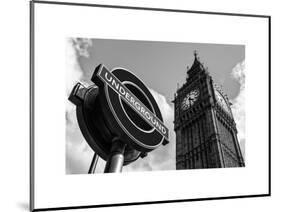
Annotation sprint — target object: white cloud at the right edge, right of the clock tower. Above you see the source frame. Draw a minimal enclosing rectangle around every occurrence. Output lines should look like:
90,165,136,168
231,61,245,158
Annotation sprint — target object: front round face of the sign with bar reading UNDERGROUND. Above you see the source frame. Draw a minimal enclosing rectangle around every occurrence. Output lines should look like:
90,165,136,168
92,64,169,152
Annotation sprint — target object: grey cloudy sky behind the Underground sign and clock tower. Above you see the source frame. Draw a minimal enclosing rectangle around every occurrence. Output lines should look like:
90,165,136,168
66,38,245,174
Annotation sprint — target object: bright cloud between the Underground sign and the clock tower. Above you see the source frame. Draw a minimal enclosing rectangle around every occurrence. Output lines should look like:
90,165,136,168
123,89,176,172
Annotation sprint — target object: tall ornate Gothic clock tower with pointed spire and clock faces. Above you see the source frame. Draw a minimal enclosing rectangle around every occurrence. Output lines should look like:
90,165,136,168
173,52,245,169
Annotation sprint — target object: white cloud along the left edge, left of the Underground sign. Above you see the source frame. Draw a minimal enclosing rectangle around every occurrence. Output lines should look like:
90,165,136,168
65,38,99,174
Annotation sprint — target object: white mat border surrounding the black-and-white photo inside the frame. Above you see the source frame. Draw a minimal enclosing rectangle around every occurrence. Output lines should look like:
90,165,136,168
31,3,269,209
